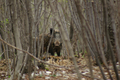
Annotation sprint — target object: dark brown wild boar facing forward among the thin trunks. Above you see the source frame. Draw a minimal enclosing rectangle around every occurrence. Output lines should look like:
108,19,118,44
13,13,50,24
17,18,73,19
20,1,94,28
33,28,62,57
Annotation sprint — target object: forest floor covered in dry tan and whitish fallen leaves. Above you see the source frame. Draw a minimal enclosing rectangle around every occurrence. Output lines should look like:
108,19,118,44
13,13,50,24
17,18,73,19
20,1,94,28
0,54,120,80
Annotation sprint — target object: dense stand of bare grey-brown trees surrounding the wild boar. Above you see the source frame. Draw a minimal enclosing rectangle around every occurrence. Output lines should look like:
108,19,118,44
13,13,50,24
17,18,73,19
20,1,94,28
0,0,120,80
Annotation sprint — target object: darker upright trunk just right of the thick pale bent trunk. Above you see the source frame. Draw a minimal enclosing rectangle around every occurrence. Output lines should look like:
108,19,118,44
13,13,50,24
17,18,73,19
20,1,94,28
25,0,34,80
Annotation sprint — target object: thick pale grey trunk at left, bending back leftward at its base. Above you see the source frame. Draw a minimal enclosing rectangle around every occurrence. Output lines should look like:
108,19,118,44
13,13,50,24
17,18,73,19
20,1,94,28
10,0,23,80
